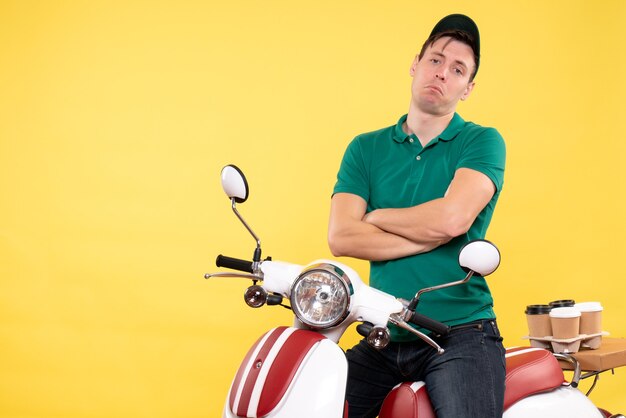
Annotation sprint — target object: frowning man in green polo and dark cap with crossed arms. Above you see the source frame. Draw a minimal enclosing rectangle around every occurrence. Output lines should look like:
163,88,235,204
328,14,505,418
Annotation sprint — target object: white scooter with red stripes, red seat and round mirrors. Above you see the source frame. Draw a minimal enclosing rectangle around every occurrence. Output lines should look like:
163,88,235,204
205,165,623,418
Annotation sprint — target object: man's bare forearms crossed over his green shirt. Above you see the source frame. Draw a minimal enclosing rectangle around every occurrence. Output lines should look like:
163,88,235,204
328,168,495,261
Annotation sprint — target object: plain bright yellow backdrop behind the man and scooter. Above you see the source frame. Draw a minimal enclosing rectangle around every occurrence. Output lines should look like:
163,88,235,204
0,0,626,418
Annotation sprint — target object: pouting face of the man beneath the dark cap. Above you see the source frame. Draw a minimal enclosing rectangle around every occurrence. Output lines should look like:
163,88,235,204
410,37,476,116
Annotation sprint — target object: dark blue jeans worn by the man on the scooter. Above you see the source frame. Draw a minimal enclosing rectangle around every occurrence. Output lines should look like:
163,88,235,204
346,320,506,418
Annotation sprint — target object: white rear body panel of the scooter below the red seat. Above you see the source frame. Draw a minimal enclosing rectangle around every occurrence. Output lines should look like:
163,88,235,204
502,386,603,418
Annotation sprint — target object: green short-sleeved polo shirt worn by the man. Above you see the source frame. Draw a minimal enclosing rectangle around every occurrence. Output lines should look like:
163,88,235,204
333,113,506,341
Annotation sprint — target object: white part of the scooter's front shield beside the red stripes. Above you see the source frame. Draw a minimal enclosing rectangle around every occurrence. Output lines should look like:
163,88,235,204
222,339,348,418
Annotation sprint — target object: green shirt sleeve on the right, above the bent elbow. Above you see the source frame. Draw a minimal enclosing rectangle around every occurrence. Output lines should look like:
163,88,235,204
456,128,506,192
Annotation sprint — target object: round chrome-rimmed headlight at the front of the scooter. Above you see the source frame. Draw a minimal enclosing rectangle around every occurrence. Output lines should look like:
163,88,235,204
290,263,353,329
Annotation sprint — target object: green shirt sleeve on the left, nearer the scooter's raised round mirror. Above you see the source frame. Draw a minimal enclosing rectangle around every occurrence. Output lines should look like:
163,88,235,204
333,137,369,202
